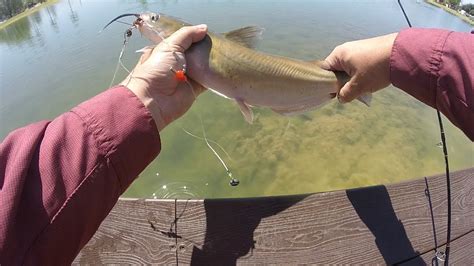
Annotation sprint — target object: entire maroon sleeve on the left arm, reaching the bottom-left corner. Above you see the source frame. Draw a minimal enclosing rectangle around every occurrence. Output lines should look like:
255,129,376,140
0,87,161,265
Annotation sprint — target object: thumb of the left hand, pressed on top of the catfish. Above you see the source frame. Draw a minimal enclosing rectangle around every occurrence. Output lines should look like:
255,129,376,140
166,24,207,52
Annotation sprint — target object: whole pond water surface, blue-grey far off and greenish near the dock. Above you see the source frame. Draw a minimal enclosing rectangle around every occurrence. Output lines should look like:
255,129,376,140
0,0,474,198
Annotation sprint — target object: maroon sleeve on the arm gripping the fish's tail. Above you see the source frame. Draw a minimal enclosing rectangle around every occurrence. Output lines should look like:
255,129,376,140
390,29,474,141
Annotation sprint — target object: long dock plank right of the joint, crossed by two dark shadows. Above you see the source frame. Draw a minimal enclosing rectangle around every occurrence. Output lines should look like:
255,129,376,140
177,169,474,264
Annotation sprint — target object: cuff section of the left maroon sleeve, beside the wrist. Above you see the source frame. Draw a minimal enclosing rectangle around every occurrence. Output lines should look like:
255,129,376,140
72,86,161,193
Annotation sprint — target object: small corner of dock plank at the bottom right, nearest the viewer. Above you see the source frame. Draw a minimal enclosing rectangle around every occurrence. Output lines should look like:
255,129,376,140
400,231,474,266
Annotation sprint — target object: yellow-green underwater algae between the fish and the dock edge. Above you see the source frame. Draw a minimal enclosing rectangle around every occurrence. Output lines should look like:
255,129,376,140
129,87,474,197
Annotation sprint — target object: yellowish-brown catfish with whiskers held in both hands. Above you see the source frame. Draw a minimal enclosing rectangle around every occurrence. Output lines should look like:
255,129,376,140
105,12,371,123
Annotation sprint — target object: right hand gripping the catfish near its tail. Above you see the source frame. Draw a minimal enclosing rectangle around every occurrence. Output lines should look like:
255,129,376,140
321,33,398,103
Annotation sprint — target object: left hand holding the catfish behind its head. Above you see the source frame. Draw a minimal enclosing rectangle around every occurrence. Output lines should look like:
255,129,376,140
120,25,207,131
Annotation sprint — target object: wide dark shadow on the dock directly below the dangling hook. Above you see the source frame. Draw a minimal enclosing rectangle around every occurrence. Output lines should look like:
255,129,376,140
191,195,309,265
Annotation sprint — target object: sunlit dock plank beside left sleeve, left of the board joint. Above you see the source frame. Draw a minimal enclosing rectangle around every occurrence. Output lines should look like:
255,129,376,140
73,199,176,265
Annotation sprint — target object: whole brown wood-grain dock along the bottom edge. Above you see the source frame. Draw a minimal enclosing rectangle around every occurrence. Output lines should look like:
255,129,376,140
74,168,474,265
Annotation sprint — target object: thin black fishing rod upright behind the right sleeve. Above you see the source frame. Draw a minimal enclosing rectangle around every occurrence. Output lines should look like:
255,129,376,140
398,0,451,265
